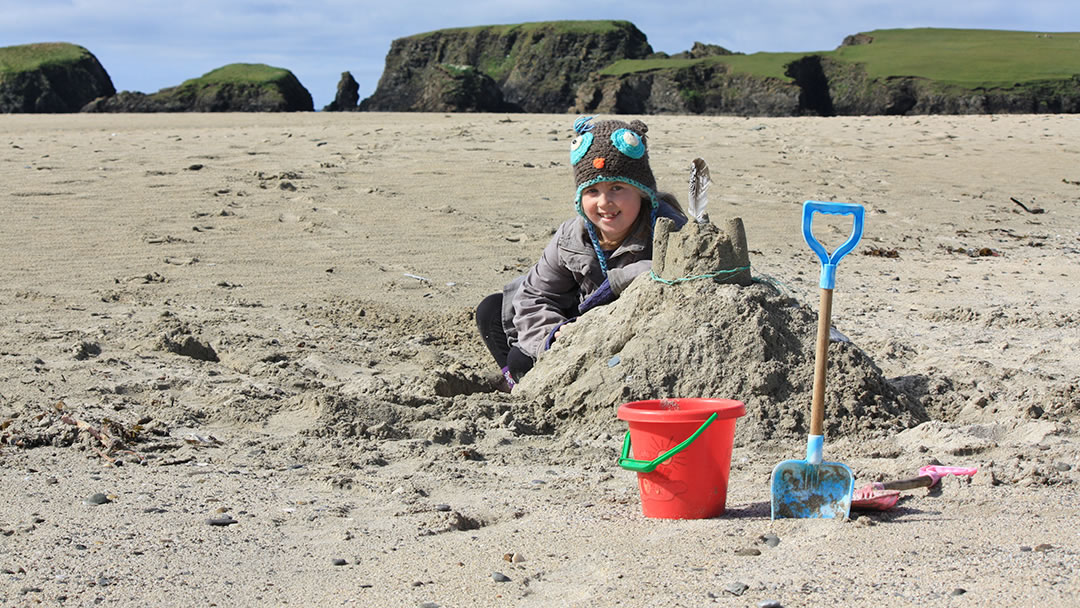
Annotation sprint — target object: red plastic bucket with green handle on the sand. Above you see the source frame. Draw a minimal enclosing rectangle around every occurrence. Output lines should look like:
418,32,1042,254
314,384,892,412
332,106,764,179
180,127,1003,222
619,398,746,519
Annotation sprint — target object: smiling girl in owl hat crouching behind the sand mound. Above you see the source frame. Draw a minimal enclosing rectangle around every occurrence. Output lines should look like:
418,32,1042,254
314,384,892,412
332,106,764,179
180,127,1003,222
476,117,686,388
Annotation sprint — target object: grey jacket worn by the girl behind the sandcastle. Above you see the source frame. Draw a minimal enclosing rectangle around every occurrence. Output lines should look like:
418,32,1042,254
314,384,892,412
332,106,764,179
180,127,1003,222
502,194,686,359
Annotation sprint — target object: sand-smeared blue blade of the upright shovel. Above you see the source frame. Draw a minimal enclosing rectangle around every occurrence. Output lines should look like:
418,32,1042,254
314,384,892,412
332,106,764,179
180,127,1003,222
772,460,855,519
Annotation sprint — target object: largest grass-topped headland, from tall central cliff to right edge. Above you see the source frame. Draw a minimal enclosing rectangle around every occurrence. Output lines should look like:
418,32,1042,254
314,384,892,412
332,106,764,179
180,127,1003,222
361,21,1080,116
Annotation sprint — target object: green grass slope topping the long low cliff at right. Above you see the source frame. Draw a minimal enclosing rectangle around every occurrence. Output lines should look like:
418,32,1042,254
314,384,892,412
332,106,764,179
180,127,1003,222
600,28,1080,89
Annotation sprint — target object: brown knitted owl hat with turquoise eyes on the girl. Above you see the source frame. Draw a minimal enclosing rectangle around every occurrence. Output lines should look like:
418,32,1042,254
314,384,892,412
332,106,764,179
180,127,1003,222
570,117,660,275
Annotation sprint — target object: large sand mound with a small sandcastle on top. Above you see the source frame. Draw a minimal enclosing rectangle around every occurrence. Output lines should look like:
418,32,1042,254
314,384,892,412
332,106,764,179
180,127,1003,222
514,218,927,443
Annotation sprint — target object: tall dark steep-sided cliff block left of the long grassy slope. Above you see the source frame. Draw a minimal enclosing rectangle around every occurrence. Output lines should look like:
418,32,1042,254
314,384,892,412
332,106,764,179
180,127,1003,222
360,22,652,112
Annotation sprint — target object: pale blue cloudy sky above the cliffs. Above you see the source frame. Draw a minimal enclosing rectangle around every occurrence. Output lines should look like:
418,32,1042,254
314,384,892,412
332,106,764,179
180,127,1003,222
0,0,1080,109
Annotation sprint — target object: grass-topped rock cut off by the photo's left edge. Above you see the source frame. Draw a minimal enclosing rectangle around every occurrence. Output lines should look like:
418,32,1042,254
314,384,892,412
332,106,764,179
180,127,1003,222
0,42,116,113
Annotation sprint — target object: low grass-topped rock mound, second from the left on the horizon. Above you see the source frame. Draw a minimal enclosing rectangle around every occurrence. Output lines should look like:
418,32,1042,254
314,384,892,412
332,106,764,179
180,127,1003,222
82,64,314,112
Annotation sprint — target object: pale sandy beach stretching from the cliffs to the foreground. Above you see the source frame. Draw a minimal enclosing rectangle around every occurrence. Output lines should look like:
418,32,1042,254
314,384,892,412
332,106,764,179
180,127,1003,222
0,113,1080,608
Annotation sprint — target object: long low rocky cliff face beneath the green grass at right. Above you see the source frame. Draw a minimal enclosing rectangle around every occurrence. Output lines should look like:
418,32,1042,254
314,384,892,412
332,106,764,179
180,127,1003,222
571,55,1080,117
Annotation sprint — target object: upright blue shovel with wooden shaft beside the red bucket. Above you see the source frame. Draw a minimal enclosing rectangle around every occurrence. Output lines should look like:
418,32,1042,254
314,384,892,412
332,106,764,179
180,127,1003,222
772,201,864,519
